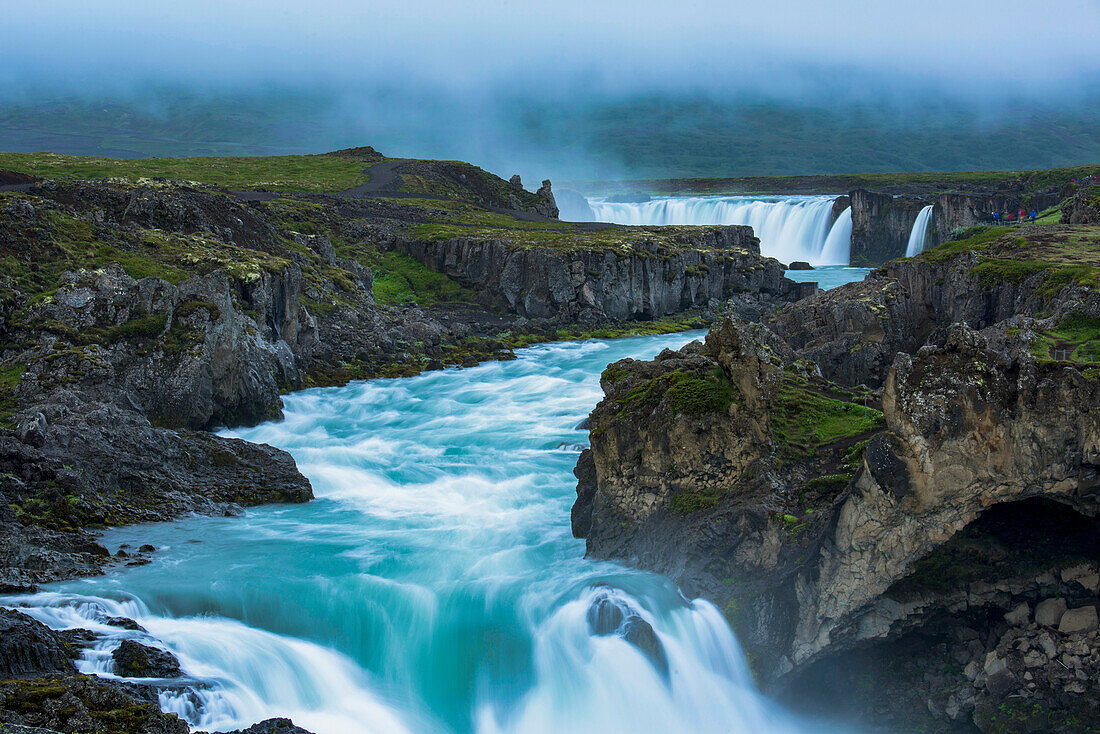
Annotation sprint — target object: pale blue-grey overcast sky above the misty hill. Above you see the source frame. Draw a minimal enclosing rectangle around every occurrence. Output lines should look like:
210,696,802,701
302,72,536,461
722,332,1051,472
0,0,1100,98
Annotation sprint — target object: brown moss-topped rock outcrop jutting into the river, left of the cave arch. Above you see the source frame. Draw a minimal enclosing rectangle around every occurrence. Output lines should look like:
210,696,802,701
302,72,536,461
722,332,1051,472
573,320,878,672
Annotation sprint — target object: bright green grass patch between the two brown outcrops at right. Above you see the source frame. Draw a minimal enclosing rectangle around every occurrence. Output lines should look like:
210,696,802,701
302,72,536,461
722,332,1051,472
770,379,884,459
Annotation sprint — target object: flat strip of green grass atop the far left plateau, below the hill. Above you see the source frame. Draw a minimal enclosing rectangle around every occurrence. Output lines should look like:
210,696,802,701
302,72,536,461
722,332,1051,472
0,153,381,193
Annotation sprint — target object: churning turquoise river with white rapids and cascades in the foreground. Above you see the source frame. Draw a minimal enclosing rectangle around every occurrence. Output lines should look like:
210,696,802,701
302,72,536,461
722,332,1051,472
0,332,849,734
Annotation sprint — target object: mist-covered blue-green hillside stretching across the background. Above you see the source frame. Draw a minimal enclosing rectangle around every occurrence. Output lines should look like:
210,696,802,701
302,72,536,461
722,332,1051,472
0,88,1100,180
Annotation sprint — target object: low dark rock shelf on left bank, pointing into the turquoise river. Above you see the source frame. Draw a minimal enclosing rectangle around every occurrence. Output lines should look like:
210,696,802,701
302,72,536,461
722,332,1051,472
0,390,312,591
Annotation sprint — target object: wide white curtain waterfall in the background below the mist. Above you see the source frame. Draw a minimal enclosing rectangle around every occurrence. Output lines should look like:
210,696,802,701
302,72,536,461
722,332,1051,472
589,196,851,265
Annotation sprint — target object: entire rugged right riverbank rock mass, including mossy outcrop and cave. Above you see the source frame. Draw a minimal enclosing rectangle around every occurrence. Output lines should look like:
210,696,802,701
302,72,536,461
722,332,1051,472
572,222,1100,732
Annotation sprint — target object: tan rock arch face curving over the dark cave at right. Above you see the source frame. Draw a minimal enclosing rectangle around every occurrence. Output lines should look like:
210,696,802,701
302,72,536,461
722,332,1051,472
791,325,1100,664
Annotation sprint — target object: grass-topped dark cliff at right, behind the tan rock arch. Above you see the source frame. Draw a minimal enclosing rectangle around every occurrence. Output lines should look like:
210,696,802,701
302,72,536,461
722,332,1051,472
773,226,1100,386
